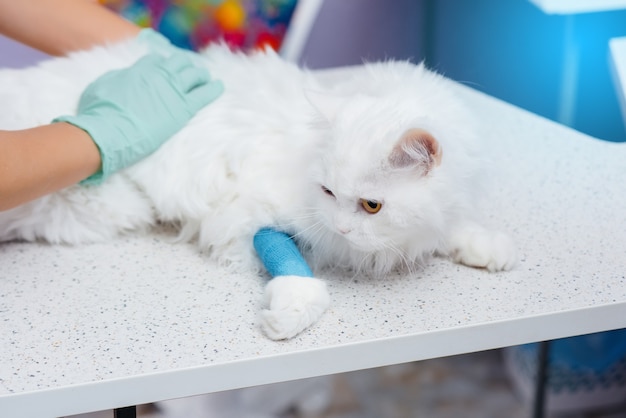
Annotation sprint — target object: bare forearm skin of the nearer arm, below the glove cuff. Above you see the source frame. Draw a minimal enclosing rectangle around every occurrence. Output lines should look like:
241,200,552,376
0,123,100,210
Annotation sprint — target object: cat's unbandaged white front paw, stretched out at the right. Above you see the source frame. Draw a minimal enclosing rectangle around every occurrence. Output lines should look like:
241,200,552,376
450,226,517,272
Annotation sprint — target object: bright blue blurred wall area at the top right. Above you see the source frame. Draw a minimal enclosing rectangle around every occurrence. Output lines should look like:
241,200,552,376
425,0,626,141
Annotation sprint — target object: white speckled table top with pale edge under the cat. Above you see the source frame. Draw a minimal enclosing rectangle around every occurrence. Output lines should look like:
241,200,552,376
0,73,626,417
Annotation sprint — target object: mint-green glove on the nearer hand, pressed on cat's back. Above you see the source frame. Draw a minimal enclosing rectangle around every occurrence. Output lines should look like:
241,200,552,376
53,53,224,184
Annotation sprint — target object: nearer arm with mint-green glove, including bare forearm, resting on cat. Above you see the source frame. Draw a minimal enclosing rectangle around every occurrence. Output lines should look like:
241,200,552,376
0,54,223,210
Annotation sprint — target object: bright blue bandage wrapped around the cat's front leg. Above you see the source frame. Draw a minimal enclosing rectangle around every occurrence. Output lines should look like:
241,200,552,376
254,228,313,277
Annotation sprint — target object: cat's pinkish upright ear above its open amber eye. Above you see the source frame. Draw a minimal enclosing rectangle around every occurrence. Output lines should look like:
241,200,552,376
389,129,442,173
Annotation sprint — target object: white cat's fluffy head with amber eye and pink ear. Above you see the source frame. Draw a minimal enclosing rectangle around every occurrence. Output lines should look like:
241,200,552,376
308,66,472,255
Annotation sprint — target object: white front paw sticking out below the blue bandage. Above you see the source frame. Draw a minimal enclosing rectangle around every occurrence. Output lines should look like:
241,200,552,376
261,276,330,340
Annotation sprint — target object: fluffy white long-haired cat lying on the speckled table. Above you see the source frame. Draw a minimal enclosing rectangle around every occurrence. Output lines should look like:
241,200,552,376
0,38,516,339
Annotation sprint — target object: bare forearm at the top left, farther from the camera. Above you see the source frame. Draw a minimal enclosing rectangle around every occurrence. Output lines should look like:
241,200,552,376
0,0,140,55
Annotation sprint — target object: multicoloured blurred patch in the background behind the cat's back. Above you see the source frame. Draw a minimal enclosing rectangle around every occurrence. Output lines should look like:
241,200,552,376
100,0,297,51
